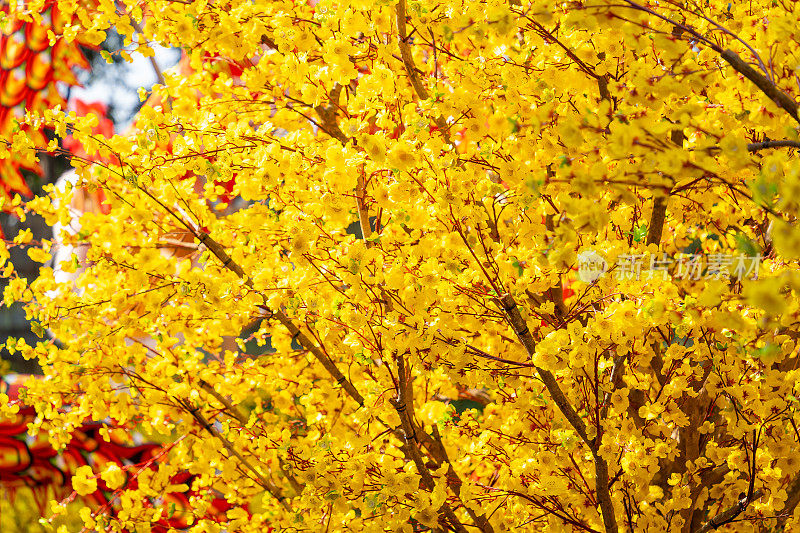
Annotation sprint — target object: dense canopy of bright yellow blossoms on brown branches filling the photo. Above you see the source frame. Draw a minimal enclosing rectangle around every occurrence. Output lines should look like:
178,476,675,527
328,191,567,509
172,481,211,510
4,0,800,532
